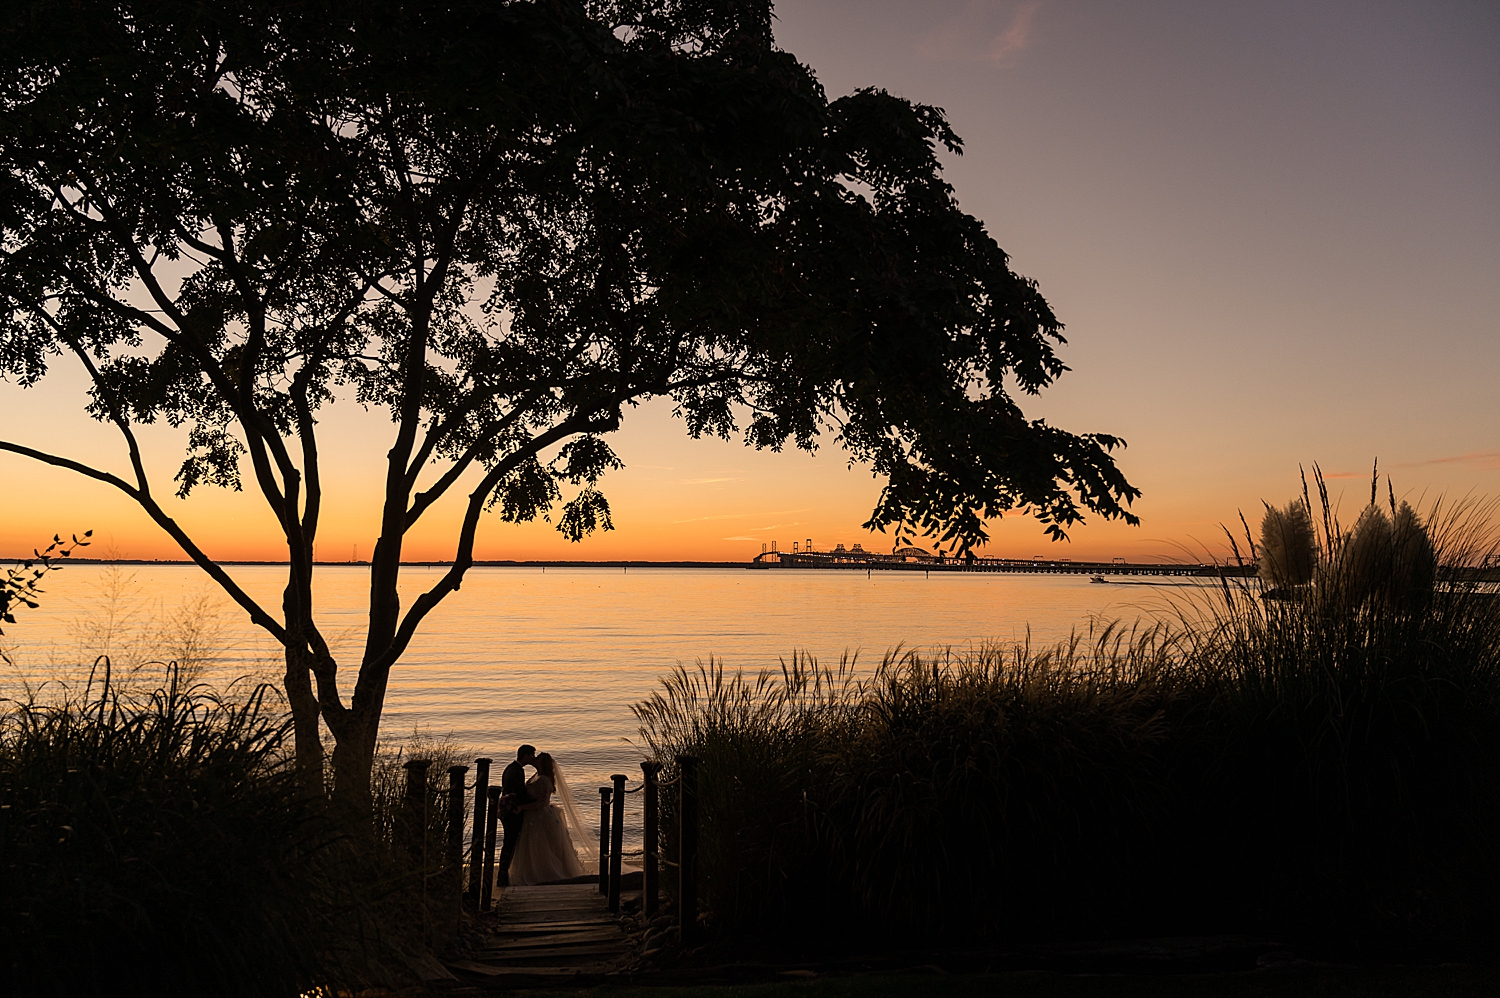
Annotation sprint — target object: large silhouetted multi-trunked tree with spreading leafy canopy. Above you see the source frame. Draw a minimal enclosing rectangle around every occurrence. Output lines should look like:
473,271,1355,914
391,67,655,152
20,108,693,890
0,0,1139,803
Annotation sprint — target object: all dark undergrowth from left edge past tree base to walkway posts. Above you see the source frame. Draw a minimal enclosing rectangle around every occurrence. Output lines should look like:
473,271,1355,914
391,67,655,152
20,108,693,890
0,665,480,995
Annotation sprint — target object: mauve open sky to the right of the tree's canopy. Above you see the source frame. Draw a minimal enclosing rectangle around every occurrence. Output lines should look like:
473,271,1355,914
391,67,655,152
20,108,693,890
762,0,1500,546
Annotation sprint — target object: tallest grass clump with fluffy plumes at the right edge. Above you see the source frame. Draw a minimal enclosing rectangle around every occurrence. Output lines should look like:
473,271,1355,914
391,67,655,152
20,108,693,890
1179,480,1500,942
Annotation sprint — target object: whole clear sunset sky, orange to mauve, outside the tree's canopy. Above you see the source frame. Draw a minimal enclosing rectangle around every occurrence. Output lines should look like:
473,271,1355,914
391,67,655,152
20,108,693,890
0,0,1500,560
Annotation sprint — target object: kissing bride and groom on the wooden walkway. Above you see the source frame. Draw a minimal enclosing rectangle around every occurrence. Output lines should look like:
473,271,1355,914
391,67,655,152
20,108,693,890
500,744,599,887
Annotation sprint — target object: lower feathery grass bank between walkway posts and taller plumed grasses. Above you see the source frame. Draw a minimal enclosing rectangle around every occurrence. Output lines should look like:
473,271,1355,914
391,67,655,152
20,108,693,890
636,629,1194,939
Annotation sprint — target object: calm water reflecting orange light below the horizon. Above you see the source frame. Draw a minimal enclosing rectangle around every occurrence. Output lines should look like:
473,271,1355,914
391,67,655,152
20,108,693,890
0,566,1194,846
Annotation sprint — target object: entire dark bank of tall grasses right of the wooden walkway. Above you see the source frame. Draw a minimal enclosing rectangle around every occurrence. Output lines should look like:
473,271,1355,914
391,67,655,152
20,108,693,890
636,510,1500,951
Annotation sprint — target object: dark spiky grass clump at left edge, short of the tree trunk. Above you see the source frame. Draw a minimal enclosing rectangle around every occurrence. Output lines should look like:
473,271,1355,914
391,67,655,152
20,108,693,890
0,662,336,995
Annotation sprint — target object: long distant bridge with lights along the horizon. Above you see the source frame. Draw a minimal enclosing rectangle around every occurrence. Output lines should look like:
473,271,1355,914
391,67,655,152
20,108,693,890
749,551,1256,578
